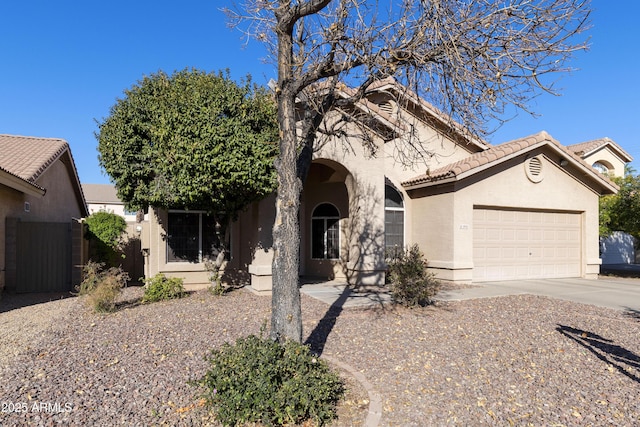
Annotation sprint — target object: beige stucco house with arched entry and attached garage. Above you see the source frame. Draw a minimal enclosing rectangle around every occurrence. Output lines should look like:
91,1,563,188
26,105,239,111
134,80,631,292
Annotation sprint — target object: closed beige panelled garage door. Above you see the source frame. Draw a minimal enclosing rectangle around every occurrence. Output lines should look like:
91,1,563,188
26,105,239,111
473,209,582,282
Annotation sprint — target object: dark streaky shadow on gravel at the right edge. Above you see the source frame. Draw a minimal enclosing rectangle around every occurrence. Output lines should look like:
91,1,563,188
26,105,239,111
556,325,640,383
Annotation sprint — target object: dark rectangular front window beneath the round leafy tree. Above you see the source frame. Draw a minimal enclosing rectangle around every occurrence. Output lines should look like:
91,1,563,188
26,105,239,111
167,211,220,262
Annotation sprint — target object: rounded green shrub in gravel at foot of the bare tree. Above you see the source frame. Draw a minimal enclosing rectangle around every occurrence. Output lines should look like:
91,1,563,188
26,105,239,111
198,335,344,426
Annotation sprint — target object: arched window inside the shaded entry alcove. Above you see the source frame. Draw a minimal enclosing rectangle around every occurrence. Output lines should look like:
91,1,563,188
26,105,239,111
311,203,340,259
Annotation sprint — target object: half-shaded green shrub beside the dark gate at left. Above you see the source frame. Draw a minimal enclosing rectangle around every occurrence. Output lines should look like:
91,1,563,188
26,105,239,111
85,211,127,267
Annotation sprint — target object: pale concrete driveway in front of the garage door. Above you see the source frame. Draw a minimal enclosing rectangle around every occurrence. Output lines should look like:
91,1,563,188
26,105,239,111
437,277,640,312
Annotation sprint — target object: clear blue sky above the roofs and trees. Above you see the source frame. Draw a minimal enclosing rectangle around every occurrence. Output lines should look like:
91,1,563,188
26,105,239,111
0,0,640,183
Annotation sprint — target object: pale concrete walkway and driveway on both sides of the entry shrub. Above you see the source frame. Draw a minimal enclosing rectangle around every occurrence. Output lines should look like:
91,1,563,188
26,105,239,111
300,276,640,312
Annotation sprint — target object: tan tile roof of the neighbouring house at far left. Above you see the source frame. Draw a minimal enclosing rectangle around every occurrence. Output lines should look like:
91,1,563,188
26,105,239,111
0,135,69,184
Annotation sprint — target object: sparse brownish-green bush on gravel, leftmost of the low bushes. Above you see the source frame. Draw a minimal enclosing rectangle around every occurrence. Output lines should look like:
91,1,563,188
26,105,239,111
76,261,129,312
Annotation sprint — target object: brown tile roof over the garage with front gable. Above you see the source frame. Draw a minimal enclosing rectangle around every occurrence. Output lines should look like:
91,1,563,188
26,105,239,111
402,131,617,193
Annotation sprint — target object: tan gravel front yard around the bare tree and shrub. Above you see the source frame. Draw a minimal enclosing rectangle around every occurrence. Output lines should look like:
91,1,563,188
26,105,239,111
0,288,640,426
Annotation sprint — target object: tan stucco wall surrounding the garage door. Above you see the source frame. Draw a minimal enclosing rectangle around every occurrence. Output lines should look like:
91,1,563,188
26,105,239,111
412,153,600,281
